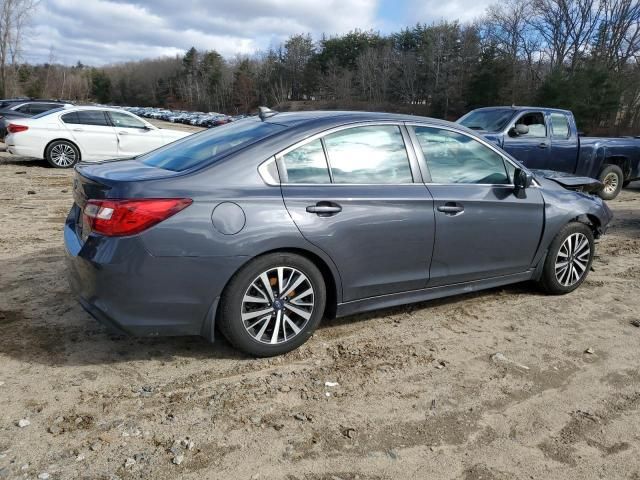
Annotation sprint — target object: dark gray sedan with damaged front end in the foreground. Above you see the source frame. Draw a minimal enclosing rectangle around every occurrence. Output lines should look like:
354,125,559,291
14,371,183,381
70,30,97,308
64,108,612,356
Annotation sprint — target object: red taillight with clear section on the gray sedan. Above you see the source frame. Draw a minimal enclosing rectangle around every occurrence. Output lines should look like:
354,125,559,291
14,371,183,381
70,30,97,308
83,198,193,237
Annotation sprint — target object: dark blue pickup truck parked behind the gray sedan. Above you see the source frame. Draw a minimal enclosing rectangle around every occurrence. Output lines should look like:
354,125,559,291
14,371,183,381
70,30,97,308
458,107,640,200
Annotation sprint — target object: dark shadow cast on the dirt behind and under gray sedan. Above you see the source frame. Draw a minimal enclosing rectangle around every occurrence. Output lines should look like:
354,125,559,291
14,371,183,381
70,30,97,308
0,248,539,366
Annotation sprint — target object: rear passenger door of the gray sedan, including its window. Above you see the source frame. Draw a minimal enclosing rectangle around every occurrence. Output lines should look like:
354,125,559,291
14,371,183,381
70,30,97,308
277,124,434,301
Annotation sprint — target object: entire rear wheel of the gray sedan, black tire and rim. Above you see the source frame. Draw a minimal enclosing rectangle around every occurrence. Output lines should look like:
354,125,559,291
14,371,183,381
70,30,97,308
218,253,326,357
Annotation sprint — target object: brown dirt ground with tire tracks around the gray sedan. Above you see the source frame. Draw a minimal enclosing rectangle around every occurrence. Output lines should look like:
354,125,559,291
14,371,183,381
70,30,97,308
0,121,640,480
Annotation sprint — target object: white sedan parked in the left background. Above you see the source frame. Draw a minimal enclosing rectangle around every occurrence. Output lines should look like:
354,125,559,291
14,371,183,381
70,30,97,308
5,107,190,168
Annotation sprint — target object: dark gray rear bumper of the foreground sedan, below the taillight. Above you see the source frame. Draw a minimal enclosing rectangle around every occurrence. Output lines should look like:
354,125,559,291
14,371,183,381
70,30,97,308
64,206,244,340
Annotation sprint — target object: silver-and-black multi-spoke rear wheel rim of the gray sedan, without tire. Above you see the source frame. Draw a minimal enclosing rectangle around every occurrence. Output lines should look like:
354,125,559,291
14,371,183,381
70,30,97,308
240,266,315,344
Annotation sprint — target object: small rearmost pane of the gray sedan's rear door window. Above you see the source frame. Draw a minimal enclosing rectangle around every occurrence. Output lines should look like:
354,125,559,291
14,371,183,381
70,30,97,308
282,139,331,183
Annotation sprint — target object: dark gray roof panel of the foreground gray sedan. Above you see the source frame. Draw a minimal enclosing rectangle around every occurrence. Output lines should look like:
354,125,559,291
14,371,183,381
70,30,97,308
264,110,460,128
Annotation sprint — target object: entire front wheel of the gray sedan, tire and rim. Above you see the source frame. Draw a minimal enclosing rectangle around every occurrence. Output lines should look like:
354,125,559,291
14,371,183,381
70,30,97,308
539,222,595,295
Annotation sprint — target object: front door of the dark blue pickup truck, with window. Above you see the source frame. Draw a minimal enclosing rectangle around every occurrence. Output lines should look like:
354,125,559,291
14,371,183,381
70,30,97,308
503,111,551,169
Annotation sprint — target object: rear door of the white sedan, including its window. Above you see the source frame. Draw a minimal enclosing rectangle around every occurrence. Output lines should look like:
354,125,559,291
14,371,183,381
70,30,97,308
60,109,118,160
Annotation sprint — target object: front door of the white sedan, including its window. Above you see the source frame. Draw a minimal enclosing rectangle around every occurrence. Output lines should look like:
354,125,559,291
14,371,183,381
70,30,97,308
108,111,165,157
